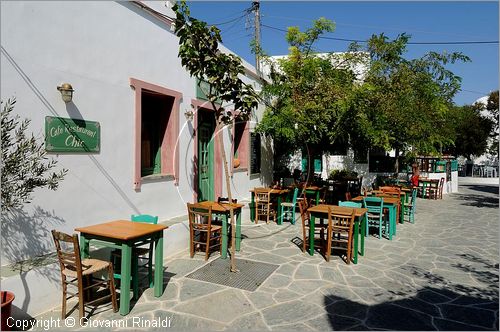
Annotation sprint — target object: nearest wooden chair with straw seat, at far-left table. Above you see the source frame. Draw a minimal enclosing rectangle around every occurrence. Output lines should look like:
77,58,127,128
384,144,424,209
52,230,118,321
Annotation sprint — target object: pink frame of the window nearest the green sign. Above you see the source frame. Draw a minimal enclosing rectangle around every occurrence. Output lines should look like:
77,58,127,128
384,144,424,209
130,78,182,190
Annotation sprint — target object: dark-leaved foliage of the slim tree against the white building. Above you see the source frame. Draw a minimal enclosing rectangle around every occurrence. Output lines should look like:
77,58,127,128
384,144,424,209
172,1,257,124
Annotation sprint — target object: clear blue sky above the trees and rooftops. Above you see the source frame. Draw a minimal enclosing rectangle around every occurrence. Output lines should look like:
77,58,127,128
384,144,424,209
189,0,499,105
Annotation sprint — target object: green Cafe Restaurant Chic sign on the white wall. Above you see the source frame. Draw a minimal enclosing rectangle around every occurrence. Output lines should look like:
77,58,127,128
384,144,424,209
45,116,101,152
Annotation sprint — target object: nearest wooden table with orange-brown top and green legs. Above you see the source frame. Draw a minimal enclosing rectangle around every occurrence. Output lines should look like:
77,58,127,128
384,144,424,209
75,220,168,315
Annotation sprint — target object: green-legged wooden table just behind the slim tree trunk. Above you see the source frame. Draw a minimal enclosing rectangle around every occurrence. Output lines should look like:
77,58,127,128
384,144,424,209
191,201,243,259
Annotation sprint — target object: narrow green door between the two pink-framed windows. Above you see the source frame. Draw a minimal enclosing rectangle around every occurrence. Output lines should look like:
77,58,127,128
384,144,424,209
198,111,215,202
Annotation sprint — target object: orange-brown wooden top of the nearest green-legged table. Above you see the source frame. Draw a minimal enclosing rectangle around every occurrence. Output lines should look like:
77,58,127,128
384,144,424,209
75,220,168,240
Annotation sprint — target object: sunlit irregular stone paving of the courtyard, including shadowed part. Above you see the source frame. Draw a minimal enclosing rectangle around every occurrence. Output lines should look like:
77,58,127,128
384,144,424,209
33,180,499,330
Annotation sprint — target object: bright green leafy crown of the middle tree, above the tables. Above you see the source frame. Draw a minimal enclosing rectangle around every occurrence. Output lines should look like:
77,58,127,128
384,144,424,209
257,18,359,159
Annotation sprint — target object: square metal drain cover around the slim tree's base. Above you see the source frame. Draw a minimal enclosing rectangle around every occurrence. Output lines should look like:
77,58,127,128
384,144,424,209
186,258,279,292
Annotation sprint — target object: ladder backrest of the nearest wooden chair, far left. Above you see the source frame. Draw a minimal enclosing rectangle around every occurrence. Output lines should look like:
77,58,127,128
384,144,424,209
52,230,82,279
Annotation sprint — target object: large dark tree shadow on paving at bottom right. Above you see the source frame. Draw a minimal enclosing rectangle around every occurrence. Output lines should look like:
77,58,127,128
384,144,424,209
324,254,499,331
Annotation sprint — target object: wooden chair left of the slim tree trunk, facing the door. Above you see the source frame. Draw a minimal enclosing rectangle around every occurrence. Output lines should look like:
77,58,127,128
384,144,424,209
187,203,222,260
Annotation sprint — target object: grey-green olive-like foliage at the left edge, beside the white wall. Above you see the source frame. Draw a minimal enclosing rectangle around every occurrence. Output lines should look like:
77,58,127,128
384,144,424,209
1,99,67,212
